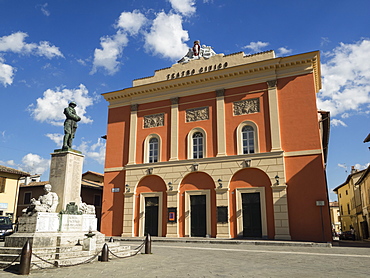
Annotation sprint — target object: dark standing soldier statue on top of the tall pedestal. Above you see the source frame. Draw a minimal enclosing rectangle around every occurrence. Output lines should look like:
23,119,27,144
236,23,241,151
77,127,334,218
62,101,81,151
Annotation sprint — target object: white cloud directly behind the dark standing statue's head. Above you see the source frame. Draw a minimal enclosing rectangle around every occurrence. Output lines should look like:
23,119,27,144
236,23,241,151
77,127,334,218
28,84,94,125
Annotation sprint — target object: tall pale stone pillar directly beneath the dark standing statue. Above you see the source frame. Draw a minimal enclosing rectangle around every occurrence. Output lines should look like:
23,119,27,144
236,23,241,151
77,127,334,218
49,150,84,212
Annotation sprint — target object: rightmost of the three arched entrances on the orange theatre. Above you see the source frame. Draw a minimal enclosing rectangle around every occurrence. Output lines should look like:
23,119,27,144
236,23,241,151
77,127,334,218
229,168,275,239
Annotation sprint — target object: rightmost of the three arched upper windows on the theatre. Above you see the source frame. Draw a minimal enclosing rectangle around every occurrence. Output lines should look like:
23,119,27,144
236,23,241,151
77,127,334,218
236,121,259,154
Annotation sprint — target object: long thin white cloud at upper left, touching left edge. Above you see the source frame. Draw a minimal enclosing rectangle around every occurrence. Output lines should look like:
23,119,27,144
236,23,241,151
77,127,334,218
0,32,64,59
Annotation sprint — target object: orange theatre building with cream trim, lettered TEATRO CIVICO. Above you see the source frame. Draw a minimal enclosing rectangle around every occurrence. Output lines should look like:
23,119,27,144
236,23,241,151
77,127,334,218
101,46,332,242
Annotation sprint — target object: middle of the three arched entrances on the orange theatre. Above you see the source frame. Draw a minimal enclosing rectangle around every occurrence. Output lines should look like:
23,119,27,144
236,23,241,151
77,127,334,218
179,172,216,237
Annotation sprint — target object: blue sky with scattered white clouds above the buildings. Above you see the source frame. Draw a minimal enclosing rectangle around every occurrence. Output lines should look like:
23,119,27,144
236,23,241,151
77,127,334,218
0,0,370,200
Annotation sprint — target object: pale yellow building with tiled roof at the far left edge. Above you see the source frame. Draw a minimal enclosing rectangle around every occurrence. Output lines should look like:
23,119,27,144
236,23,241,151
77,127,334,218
0,165,30,221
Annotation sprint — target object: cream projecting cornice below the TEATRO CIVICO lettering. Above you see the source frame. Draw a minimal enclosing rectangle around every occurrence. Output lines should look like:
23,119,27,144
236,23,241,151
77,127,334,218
103,51,321,108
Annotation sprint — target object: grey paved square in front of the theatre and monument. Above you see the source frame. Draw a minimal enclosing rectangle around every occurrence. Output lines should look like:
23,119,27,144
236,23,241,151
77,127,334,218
0,241,370,278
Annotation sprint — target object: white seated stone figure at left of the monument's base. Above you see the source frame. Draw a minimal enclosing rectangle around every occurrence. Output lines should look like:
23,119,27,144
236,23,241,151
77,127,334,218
23,184,58,215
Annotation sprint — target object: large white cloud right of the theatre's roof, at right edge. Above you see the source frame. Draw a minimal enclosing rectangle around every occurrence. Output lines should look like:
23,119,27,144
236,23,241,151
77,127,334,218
317,39,370,118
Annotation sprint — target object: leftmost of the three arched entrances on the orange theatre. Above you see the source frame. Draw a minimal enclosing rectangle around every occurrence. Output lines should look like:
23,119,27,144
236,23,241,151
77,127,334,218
134,175,167,236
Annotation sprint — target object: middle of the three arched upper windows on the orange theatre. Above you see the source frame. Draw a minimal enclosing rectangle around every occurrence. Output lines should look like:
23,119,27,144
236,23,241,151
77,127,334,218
187,127,207,159
